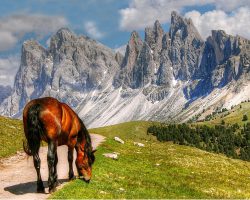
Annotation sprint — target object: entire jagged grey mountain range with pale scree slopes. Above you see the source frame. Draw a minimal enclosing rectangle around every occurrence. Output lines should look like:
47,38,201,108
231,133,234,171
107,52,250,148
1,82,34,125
0,12,250,127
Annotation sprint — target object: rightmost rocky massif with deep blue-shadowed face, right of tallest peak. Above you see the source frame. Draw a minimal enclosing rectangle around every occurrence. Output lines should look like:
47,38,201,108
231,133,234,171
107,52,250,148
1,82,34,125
185,30,250,98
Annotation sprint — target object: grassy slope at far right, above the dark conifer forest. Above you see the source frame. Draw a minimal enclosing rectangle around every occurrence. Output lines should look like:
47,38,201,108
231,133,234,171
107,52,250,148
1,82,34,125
200,102,250,125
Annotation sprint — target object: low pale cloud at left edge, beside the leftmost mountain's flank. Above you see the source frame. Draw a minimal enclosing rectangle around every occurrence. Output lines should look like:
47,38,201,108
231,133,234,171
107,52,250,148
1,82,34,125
0,55,20,86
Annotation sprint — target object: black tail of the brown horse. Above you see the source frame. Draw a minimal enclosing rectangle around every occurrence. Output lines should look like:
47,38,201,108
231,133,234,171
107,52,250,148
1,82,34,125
23,104,43,156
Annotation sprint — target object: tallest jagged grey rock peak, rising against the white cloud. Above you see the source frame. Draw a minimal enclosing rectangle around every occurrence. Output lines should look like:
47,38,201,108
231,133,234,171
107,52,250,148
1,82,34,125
169,12,204,81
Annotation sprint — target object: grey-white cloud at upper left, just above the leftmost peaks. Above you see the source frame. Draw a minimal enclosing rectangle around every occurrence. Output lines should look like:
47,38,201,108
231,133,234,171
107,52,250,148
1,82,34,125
0,14,68,51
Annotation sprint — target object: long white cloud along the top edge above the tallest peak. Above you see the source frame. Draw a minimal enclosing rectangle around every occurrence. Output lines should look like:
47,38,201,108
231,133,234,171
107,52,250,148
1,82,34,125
120,0,250,31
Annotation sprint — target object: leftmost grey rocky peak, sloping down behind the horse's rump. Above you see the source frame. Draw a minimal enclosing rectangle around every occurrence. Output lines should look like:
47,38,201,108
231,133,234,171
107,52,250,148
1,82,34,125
0,40,47,116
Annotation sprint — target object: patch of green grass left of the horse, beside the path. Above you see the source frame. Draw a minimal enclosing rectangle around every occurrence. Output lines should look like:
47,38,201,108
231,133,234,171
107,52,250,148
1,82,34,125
0,116,24,158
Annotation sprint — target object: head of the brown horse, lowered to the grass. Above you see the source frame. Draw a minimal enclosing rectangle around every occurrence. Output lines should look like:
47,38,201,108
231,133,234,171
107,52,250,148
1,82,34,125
76,147,96,183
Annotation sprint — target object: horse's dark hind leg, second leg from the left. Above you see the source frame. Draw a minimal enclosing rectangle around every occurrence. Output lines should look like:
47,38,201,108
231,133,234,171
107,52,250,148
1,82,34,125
47,141,57,193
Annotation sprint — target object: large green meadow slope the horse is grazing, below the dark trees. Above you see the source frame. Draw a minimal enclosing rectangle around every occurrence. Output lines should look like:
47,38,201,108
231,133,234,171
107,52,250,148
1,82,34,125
51,122,250,199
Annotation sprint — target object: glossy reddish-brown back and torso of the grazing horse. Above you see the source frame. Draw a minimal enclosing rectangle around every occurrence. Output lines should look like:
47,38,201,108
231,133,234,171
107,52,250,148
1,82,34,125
23,97,81,144
